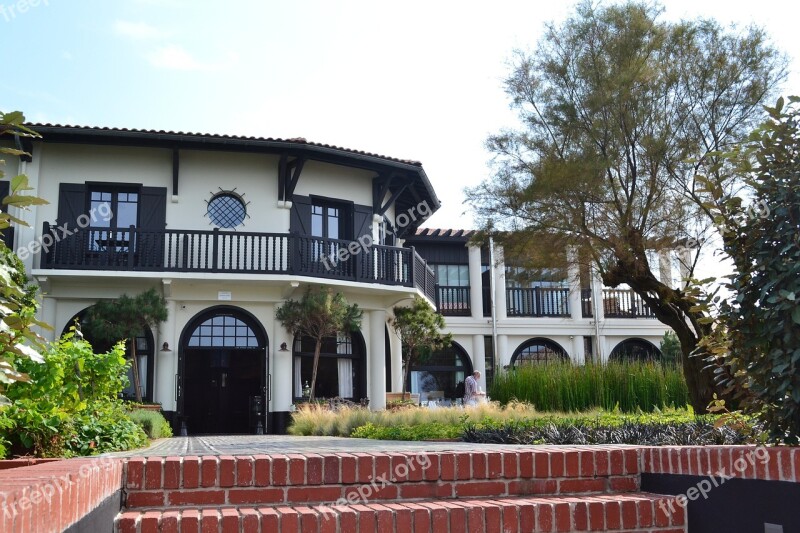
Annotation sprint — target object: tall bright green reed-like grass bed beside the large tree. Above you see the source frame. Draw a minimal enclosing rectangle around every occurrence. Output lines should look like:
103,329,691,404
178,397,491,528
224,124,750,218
488,362,689,413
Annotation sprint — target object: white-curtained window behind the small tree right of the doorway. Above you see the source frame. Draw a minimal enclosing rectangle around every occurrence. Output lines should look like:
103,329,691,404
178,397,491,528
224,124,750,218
292,332,366,401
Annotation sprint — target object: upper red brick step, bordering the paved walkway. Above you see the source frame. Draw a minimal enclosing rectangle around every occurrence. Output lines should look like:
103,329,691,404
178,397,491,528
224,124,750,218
124,447,640,508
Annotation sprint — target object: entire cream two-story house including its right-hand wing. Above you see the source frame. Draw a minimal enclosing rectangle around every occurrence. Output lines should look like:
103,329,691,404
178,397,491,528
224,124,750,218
0,124,671,434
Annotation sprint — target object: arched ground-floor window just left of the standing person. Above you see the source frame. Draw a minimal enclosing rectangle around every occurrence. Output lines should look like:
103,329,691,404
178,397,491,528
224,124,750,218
408,342,472,401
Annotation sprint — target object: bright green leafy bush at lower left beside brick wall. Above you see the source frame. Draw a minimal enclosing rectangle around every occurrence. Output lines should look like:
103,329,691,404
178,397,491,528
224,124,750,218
0,333,147,457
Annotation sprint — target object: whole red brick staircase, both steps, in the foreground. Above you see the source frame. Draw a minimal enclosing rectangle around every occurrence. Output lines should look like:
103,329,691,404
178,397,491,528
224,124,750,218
115,446,686,533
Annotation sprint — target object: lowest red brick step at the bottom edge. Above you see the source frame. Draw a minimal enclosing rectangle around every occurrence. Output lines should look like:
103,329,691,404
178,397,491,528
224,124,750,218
115,493,686,533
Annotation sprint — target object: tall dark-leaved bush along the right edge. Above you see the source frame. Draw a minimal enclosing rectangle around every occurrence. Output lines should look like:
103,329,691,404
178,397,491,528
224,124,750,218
708,96,800,445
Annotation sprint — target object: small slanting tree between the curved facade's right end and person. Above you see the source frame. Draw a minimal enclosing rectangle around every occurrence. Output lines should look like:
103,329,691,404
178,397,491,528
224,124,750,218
389,296,453,399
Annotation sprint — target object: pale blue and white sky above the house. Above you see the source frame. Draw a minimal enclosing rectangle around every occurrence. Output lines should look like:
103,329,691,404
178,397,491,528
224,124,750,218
0,0,800,237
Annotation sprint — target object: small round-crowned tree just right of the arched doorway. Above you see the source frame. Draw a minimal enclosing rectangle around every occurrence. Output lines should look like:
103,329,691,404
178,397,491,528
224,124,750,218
275,286,363,402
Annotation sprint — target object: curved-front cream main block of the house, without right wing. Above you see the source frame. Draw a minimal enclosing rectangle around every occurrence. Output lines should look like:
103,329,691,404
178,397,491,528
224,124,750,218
3,125,439,433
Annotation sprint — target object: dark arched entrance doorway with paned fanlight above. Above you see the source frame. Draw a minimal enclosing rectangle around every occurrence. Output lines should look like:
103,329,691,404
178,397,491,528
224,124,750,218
178,306,268,435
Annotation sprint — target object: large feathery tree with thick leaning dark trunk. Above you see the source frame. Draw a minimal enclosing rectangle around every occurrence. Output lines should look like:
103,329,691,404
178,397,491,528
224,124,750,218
467,3,786,412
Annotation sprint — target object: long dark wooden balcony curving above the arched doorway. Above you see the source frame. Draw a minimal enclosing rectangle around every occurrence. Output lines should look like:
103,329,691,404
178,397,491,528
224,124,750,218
41,223,436,302
